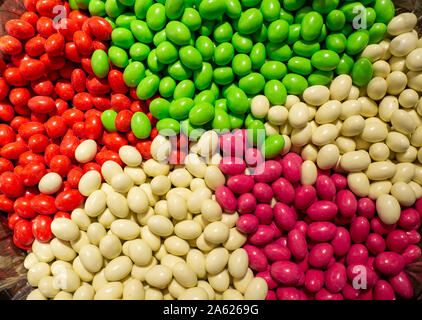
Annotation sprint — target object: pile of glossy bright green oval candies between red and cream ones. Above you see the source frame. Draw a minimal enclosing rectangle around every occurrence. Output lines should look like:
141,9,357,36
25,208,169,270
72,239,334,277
71,0,394,142
